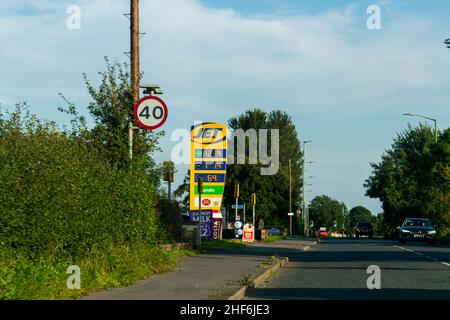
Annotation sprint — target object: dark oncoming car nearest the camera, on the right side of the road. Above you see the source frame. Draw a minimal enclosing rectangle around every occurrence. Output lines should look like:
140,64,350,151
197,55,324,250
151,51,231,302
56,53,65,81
398,218,436,244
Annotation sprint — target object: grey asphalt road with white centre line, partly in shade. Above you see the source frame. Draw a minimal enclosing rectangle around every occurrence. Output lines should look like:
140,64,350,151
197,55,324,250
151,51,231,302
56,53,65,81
246,238,450,300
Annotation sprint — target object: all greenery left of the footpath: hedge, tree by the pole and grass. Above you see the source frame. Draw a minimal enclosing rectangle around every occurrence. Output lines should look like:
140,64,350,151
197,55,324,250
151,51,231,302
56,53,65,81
0,60,178,299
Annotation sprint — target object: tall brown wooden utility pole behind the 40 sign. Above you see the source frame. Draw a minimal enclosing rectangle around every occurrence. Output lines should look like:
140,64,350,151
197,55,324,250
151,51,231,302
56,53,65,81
128,0,140,164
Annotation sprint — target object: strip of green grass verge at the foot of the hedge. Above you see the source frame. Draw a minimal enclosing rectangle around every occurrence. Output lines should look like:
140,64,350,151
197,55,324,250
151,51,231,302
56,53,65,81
0,245,195,300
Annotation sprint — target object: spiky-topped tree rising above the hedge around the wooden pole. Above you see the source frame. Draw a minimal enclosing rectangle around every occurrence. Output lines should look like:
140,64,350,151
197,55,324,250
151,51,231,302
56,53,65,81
60,57,164,180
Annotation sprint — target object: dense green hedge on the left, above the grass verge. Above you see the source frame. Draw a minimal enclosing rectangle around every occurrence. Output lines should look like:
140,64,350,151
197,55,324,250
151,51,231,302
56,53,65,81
0,106,159,260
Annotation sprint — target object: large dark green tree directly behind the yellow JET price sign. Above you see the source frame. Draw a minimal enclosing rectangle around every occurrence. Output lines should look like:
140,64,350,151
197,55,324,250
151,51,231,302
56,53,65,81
224,109,302,229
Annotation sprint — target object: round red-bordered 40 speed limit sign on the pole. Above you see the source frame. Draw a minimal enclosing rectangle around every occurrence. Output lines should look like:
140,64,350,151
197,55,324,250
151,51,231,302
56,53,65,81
134,96,168,130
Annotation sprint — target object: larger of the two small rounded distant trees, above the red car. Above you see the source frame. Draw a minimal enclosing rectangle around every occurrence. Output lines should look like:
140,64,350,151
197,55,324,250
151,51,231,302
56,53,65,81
309,195,349,230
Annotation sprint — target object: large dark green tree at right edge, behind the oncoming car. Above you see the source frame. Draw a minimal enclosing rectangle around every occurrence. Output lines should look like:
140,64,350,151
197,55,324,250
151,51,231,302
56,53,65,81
364,125,450,233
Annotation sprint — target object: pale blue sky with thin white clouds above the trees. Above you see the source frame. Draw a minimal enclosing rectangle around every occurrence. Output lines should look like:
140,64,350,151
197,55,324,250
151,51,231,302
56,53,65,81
0,0,450,213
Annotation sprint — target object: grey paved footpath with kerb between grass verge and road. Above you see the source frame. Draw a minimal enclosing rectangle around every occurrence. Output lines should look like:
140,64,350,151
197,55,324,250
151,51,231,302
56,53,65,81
81,239,316,300
